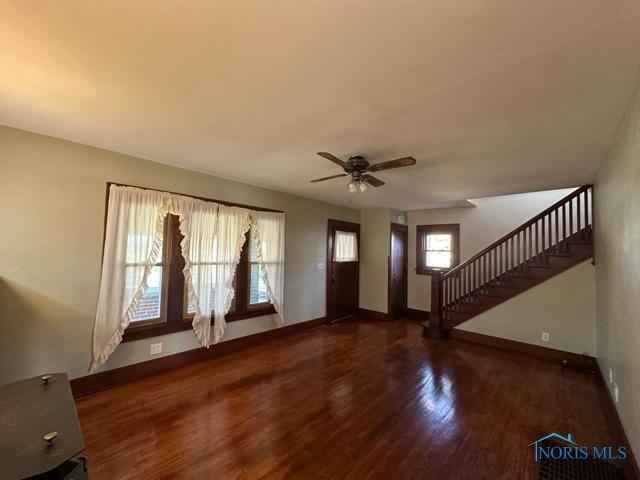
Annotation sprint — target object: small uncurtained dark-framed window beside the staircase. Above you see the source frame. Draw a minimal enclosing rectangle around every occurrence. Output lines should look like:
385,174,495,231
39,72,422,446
416,223,460,275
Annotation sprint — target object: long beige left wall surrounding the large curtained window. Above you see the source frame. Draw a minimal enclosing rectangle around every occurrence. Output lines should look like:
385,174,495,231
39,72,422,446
0,127,360,383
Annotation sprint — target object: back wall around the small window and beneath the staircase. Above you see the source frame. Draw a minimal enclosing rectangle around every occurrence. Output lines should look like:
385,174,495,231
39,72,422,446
408,189,595,354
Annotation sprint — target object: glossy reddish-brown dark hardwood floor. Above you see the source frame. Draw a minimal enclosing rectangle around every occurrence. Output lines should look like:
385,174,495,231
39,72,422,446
77,321,615,480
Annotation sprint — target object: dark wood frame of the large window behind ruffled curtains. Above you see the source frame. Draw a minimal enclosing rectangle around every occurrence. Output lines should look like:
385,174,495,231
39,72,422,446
103,182,282,342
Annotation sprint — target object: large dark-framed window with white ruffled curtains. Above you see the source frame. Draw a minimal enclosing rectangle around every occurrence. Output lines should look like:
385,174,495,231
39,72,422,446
89,183,286,372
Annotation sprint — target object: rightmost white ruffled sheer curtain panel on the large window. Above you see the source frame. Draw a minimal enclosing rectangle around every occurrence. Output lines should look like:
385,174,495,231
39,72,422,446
251,212,285,325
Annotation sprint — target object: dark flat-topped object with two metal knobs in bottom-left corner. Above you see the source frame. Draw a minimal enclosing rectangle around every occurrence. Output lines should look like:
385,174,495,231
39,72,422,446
0,373,86,480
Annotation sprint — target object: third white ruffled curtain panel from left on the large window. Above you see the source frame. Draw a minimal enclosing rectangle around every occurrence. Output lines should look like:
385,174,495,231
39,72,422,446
213,205,251,343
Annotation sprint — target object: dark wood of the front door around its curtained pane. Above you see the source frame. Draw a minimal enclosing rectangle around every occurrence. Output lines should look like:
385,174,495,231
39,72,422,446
327,220,360,321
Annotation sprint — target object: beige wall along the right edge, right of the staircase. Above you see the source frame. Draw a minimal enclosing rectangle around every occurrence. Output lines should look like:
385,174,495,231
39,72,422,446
594,81,640,458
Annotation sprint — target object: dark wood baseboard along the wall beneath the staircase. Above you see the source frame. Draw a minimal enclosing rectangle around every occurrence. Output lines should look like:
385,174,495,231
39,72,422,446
449,328,598,372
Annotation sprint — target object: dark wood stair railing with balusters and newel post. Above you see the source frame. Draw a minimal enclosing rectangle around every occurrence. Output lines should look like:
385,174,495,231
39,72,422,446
427,185,593,337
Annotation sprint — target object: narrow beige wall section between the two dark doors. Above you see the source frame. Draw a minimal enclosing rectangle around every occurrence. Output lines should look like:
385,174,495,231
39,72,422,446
360,208,392,313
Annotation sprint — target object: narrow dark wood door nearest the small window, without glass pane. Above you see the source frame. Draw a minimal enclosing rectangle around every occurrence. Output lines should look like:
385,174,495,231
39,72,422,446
389,223,409,317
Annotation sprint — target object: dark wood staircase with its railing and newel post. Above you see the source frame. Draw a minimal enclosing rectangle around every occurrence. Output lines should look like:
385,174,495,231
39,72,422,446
425,185,593,338
